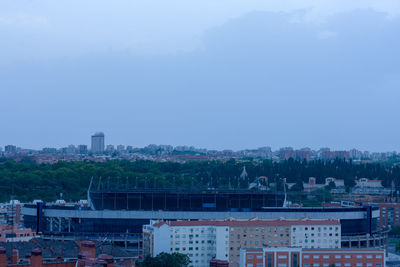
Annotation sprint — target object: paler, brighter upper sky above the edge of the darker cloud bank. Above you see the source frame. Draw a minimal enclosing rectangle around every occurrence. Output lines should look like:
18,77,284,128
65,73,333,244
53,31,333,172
0,0,400,64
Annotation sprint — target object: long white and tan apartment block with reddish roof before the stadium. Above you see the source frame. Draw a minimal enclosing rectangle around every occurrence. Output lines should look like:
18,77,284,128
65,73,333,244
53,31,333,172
143,219,341,267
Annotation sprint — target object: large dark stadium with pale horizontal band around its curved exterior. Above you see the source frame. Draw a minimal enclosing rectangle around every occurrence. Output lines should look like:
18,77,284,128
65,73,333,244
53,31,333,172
21,186,386,249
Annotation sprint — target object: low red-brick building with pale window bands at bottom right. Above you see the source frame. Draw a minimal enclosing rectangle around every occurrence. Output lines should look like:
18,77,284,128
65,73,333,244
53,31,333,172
240,247,385,267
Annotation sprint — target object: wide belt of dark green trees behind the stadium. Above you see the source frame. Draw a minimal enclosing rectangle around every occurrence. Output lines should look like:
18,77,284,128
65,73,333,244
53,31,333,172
0,159,400,202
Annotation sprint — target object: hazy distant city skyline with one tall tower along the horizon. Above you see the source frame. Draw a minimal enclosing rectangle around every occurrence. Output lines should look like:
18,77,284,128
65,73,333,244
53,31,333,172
0,132,400,165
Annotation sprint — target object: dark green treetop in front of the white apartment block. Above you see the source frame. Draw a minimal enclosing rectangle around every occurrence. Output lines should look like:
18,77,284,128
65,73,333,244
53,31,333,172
138,253,190,267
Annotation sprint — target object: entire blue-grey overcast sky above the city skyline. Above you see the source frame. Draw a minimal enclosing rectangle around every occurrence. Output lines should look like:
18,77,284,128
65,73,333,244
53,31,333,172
0,0,400,151
